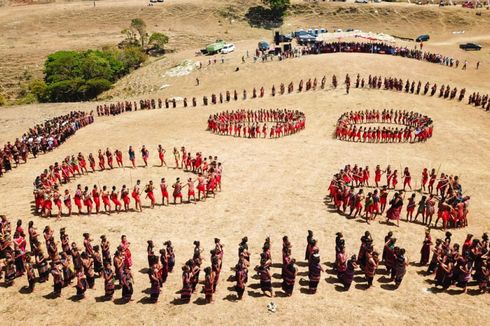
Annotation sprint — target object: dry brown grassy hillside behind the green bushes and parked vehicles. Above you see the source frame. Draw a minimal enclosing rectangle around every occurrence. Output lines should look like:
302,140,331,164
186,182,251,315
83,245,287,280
0,0,490,102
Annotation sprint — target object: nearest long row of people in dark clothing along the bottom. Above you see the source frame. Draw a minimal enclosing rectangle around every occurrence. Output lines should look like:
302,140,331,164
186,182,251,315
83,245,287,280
0,217,490,303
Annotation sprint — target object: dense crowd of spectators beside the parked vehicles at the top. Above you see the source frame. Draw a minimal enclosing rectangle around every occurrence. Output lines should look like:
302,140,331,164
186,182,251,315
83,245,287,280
302,42,468,69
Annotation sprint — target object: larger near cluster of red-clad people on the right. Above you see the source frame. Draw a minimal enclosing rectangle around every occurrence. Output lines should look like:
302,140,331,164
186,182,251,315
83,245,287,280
329,164,470,230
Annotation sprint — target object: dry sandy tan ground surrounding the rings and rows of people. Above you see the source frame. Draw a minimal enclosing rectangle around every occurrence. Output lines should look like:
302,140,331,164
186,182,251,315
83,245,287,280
0,0,490,325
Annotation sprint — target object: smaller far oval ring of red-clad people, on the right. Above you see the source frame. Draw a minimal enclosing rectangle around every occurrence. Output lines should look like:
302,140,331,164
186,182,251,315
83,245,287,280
335,109,433,143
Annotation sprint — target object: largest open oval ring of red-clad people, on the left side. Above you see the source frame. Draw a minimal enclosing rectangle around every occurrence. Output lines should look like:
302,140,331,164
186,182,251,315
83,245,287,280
33,145,223,219
